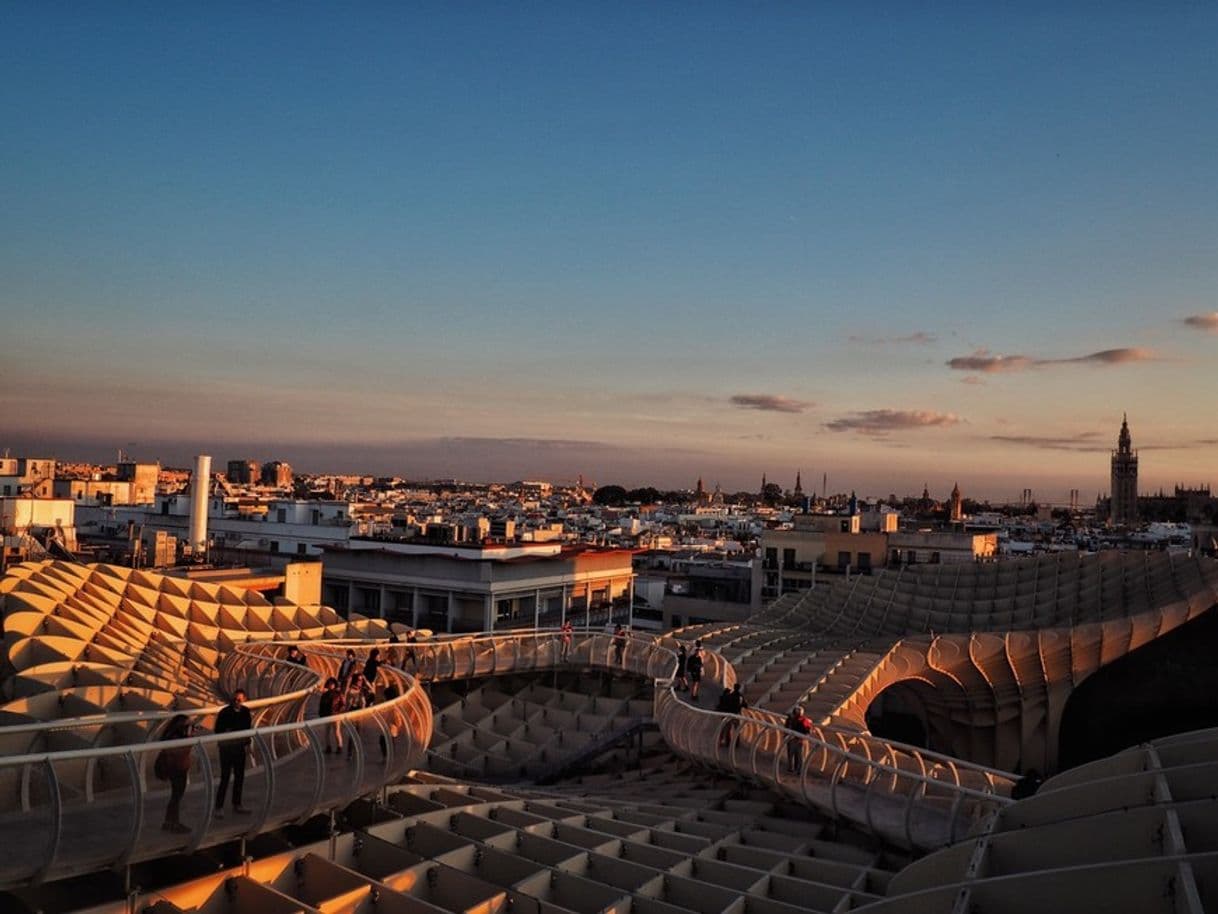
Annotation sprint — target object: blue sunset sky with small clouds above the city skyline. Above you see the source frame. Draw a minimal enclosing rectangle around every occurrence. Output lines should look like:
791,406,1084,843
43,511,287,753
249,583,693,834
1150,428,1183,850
0,2,1218,501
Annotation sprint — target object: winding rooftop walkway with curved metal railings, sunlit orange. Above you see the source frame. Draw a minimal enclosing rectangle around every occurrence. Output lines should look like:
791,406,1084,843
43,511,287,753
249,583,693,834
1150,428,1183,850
0,631,1010,885
